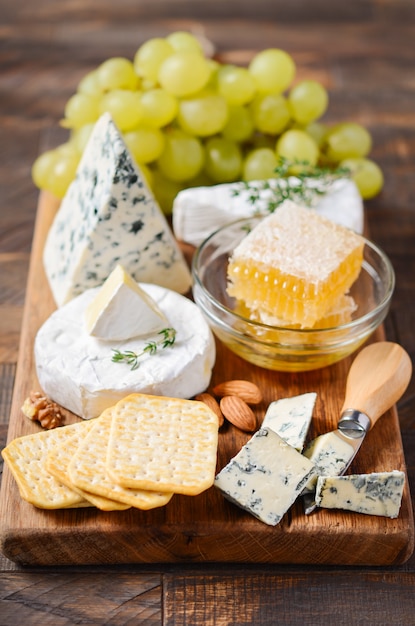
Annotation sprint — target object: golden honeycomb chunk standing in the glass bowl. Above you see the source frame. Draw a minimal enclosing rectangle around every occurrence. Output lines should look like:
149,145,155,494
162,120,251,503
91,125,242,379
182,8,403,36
227,203,364,328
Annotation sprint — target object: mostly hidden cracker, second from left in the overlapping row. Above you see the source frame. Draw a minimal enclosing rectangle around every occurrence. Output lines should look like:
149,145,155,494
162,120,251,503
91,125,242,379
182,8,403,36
46,418,130,511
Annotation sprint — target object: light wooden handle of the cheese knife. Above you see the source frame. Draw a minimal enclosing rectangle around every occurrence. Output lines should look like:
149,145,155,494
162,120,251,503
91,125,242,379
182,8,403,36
342,341,412,427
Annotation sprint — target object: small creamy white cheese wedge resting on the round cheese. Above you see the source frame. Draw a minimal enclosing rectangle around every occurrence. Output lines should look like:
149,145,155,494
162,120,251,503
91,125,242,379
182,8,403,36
85,265,169,341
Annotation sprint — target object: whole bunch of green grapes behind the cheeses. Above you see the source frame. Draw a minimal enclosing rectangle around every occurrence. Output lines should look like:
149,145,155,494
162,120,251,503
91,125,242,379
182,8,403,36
32,31,383,213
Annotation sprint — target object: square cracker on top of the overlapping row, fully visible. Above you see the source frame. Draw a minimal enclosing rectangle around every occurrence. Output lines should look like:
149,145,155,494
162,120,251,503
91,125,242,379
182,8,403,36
107,394,218,495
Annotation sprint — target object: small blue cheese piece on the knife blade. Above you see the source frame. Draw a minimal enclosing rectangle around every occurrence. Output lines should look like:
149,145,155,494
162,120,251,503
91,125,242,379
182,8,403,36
303,431,354,490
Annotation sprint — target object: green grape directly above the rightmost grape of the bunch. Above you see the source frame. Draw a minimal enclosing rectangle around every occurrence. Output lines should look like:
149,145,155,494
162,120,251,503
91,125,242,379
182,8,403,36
325,122,372,162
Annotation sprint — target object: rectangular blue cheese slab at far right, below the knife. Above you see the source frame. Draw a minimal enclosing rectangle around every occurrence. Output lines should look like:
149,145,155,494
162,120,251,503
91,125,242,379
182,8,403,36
316,470,405,518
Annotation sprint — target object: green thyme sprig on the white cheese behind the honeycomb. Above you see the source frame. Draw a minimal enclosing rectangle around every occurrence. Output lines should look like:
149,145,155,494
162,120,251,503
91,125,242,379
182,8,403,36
232,157,350,213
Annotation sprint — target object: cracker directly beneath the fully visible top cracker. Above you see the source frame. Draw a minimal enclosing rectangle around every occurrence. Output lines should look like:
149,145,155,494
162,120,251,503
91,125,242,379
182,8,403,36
68,407,173,510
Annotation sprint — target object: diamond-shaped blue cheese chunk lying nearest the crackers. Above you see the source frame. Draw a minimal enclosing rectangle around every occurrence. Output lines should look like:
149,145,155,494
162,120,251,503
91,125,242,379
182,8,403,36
215,428,315,526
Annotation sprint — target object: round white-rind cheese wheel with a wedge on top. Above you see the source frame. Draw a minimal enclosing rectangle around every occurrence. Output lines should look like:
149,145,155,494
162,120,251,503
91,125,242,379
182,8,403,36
35,283,215,419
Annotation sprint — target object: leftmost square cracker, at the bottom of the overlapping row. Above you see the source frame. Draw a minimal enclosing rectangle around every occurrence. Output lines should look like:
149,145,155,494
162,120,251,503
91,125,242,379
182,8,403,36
2,422,91,509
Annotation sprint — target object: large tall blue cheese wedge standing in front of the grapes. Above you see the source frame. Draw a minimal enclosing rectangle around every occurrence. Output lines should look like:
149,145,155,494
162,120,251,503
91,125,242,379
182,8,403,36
43,113,191,306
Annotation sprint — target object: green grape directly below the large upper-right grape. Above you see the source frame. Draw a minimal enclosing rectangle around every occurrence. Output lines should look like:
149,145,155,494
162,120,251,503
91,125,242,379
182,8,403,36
249,94,290,135
